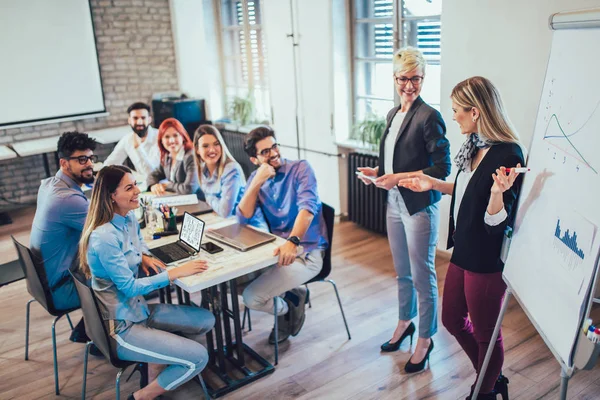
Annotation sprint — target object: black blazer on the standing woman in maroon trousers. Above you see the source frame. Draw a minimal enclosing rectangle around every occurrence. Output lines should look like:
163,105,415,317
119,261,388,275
448,143,525,273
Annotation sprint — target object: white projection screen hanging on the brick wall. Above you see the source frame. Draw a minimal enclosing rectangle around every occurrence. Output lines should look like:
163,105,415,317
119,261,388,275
0,0,106,128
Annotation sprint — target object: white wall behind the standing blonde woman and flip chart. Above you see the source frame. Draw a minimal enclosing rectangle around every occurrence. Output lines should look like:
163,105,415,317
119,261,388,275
439,0,600,248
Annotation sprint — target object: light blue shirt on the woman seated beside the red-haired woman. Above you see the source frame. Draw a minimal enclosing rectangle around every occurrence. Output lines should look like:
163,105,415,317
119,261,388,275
200,161,245,218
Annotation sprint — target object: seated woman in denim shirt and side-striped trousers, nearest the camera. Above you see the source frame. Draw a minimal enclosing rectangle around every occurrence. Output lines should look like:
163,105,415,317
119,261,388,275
79,165,215,399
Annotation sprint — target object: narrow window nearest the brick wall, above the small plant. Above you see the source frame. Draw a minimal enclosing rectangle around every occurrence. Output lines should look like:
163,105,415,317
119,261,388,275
215,0,271,121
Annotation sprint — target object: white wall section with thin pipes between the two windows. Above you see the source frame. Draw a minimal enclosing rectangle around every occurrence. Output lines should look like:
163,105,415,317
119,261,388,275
263,0,340,212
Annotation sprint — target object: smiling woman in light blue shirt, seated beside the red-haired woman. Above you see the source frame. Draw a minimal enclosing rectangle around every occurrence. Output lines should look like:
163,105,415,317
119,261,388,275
194,125,246,218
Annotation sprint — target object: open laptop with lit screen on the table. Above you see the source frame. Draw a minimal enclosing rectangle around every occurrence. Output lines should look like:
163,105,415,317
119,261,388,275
150,212,204,264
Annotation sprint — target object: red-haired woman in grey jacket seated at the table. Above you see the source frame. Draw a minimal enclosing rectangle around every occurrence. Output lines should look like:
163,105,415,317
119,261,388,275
148,118,199,196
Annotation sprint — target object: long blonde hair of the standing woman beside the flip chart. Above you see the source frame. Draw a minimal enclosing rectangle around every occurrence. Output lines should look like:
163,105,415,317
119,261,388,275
450,76,523,147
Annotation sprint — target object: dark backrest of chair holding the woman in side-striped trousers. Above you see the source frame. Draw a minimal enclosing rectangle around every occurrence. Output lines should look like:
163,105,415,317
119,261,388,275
71,272,130,368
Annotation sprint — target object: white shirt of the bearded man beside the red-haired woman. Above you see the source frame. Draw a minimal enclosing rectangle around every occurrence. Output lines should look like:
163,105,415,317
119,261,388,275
104,126,160,180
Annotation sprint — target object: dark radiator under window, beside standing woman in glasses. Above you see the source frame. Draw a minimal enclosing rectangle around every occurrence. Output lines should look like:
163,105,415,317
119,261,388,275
348,153,386,234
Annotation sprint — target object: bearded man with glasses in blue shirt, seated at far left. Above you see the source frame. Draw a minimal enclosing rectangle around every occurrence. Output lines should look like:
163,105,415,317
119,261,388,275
30,132,99,354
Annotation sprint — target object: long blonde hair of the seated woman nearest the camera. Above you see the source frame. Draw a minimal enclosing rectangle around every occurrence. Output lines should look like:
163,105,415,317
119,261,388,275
79,165,131,279
